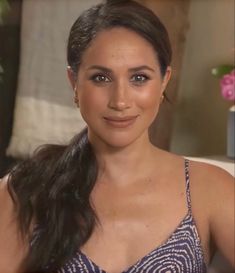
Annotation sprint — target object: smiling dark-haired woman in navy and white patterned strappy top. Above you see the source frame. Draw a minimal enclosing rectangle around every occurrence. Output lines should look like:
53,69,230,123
0,1,234,273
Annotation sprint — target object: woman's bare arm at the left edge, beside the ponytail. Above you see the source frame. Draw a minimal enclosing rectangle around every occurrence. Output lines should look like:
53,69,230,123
0,175,26,273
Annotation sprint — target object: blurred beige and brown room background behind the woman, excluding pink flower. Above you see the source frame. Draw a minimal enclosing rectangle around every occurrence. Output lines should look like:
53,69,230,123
0,0,234,268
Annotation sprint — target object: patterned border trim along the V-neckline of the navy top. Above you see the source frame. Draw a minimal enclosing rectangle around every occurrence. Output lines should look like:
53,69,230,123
77,210,194,273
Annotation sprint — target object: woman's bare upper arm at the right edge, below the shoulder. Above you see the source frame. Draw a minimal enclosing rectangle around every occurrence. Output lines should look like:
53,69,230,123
208,167,235,266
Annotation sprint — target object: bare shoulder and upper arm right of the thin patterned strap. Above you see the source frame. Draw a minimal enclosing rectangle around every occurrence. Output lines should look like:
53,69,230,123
190,161,235,266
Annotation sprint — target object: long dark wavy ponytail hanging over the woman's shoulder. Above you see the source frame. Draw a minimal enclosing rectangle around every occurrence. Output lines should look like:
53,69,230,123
8,129,97,272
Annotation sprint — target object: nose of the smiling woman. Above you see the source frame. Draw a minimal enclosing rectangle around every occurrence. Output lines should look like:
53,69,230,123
108,83,132,111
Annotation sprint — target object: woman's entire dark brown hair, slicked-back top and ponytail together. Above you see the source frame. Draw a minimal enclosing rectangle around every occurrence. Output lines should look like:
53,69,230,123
8,0,171,272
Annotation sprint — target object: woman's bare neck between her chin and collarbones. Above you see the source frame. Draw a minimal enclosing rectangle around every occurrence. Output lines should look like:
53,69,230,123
91,131,158,185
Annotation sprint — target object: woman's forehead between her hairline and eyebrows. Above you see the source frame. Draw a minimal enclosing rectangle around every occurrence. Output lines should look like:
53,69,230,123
81,27,159,67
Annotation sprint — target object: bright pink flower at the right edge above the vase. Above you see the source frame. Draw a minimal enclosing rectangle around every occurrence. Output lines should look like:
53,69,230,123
220,70,235,102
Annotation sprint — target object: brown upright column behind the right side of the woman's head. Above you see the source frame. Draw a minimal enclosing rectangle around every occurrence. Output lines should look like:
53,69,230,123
139,0,190,150
